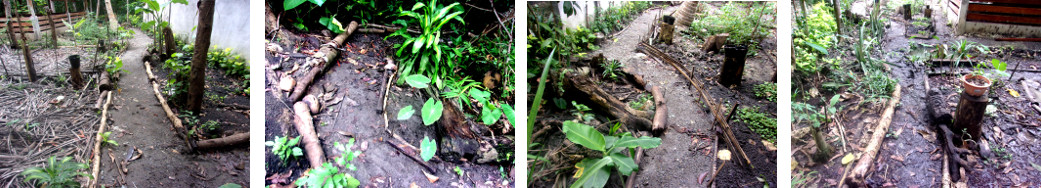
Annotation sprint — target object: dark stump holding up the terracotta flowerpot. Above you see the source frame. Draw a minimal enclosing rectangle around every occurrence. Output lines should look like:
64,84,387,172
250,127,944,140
951,92,989,141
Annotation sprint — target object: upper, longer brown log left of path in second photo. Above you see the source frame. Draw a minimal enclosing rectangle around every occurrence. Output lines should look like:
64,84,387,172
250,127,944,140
289,21,358,101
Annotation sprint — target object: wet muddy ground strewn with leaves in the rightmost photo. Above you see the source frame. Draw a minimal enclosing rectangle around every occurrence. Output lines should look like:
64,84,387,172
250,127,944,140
792,1,1041,187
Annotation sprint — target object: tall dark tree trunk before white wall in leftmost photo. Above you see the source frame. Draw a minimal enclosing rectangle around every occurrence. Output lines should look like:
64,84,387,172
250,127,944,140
188,0,214,114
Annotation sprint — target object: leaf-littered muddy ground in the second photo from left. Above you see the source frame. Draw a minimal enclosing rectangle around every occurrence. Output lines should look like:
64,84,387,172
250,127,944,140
264,27,513,187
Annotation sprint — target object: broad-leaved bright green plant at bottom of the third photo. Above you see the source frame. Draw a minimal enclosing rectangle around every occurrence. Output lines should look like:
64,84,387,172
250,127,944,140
563,120,661,188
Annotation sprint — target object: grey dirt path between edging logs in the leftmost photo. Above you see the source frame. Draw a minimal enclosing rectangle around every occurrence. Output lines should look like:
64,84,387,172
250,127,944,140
98,29,249,187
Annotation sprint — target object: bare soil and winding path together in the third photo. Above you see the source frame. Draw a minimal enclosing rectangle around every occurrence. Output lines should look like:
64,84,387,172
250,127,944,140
531,4,777,187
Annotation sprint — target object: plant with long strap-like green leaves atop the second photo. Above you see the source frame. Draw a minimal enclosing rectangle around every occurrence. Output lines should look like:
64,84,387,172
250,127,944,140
386,0,465,83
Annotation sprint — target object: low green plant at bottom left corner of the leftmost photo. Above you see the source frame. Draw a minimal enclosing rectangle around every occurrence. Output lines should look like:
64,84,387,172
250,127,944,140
21,156,92,187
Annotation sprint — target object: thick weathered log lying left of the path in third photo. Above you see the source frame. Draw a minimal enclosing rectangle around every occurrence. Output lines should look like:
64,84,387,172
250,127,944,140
564,72,654,130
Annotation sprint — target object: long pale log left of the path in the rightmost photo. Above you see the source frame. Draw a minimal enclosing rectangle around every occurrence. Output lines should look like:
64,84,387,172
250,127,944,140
847,86,900,186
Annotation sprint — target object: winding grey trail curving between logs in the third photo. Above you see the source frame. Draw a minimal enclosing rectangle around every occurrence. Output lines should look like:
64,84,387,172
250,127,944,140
590,6,716,187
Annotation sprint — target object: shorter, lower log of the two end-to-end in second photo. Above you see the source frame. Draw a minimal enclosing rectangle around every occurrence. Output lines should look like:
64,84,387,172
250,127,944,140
293,102,325,167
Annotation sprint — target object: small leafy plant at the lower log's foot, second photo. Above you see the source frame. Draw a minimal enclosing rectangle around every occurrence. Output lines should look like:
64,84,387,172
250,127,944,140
296,138,361,188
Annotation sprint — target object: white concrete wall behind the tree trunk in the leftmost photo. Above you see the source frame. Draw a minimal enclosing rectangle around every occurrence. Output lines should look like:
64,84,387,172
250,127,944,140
153,0,248,60
